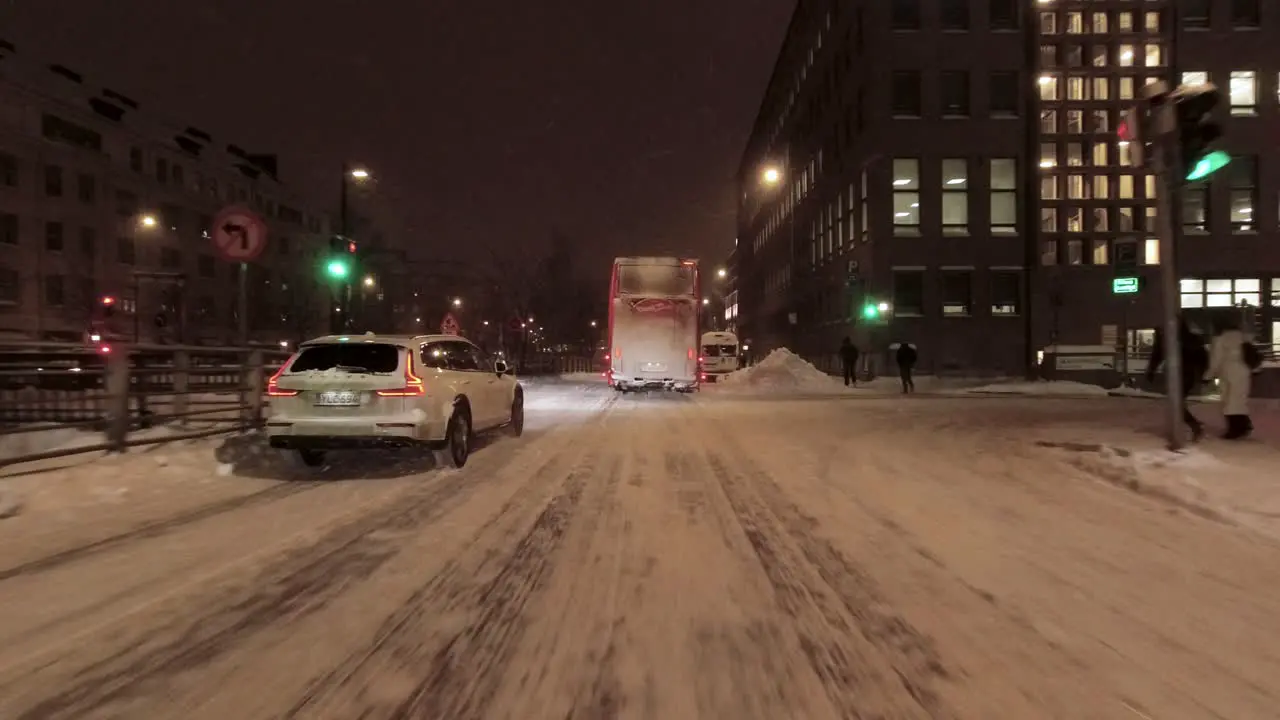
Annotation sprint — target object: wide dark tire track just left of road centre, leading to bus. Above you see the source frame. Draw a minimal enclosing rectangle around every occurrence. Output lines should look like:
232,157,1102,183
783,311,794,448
283,397,620,720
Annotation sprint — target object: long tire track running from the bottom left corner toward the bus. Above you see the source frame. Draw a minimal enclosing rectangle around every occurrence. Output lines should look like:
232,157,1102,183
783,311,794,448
3,398,613,720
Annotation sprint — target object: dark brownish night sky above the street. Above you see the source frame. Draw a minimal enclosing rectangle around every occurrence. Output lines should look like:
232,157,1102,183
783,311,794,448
0,0,795,273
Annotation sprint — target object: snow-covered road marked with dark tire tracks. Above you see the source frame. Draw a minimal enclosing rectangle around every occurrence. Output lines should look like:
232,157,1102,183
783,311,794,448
0,383,1280,720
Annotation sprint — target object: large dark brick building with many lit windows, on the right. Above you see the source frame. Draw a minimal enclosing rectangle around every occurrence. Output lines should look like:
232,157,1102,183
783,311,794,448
735,0,1280,374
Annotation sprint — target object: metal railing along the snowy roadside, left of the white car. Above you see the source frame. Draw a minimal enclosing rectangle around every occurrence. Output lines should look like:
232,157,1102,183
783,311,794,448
0,342,288,466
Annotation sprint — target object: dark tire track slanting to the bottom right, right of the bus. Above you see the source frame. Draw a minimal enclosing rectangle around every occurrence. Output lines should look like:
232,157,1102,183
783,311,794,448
707,424,955,719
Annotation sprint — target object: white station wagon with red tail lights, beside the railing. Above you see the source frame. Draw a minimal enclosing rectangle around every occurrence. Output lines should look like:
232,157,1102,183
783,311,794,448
266,333,525,468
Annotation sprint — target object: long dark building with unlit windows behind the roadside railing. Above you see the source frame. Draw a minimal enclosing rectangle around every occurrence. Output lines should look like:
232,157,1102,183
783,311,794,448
0,41,330,343
